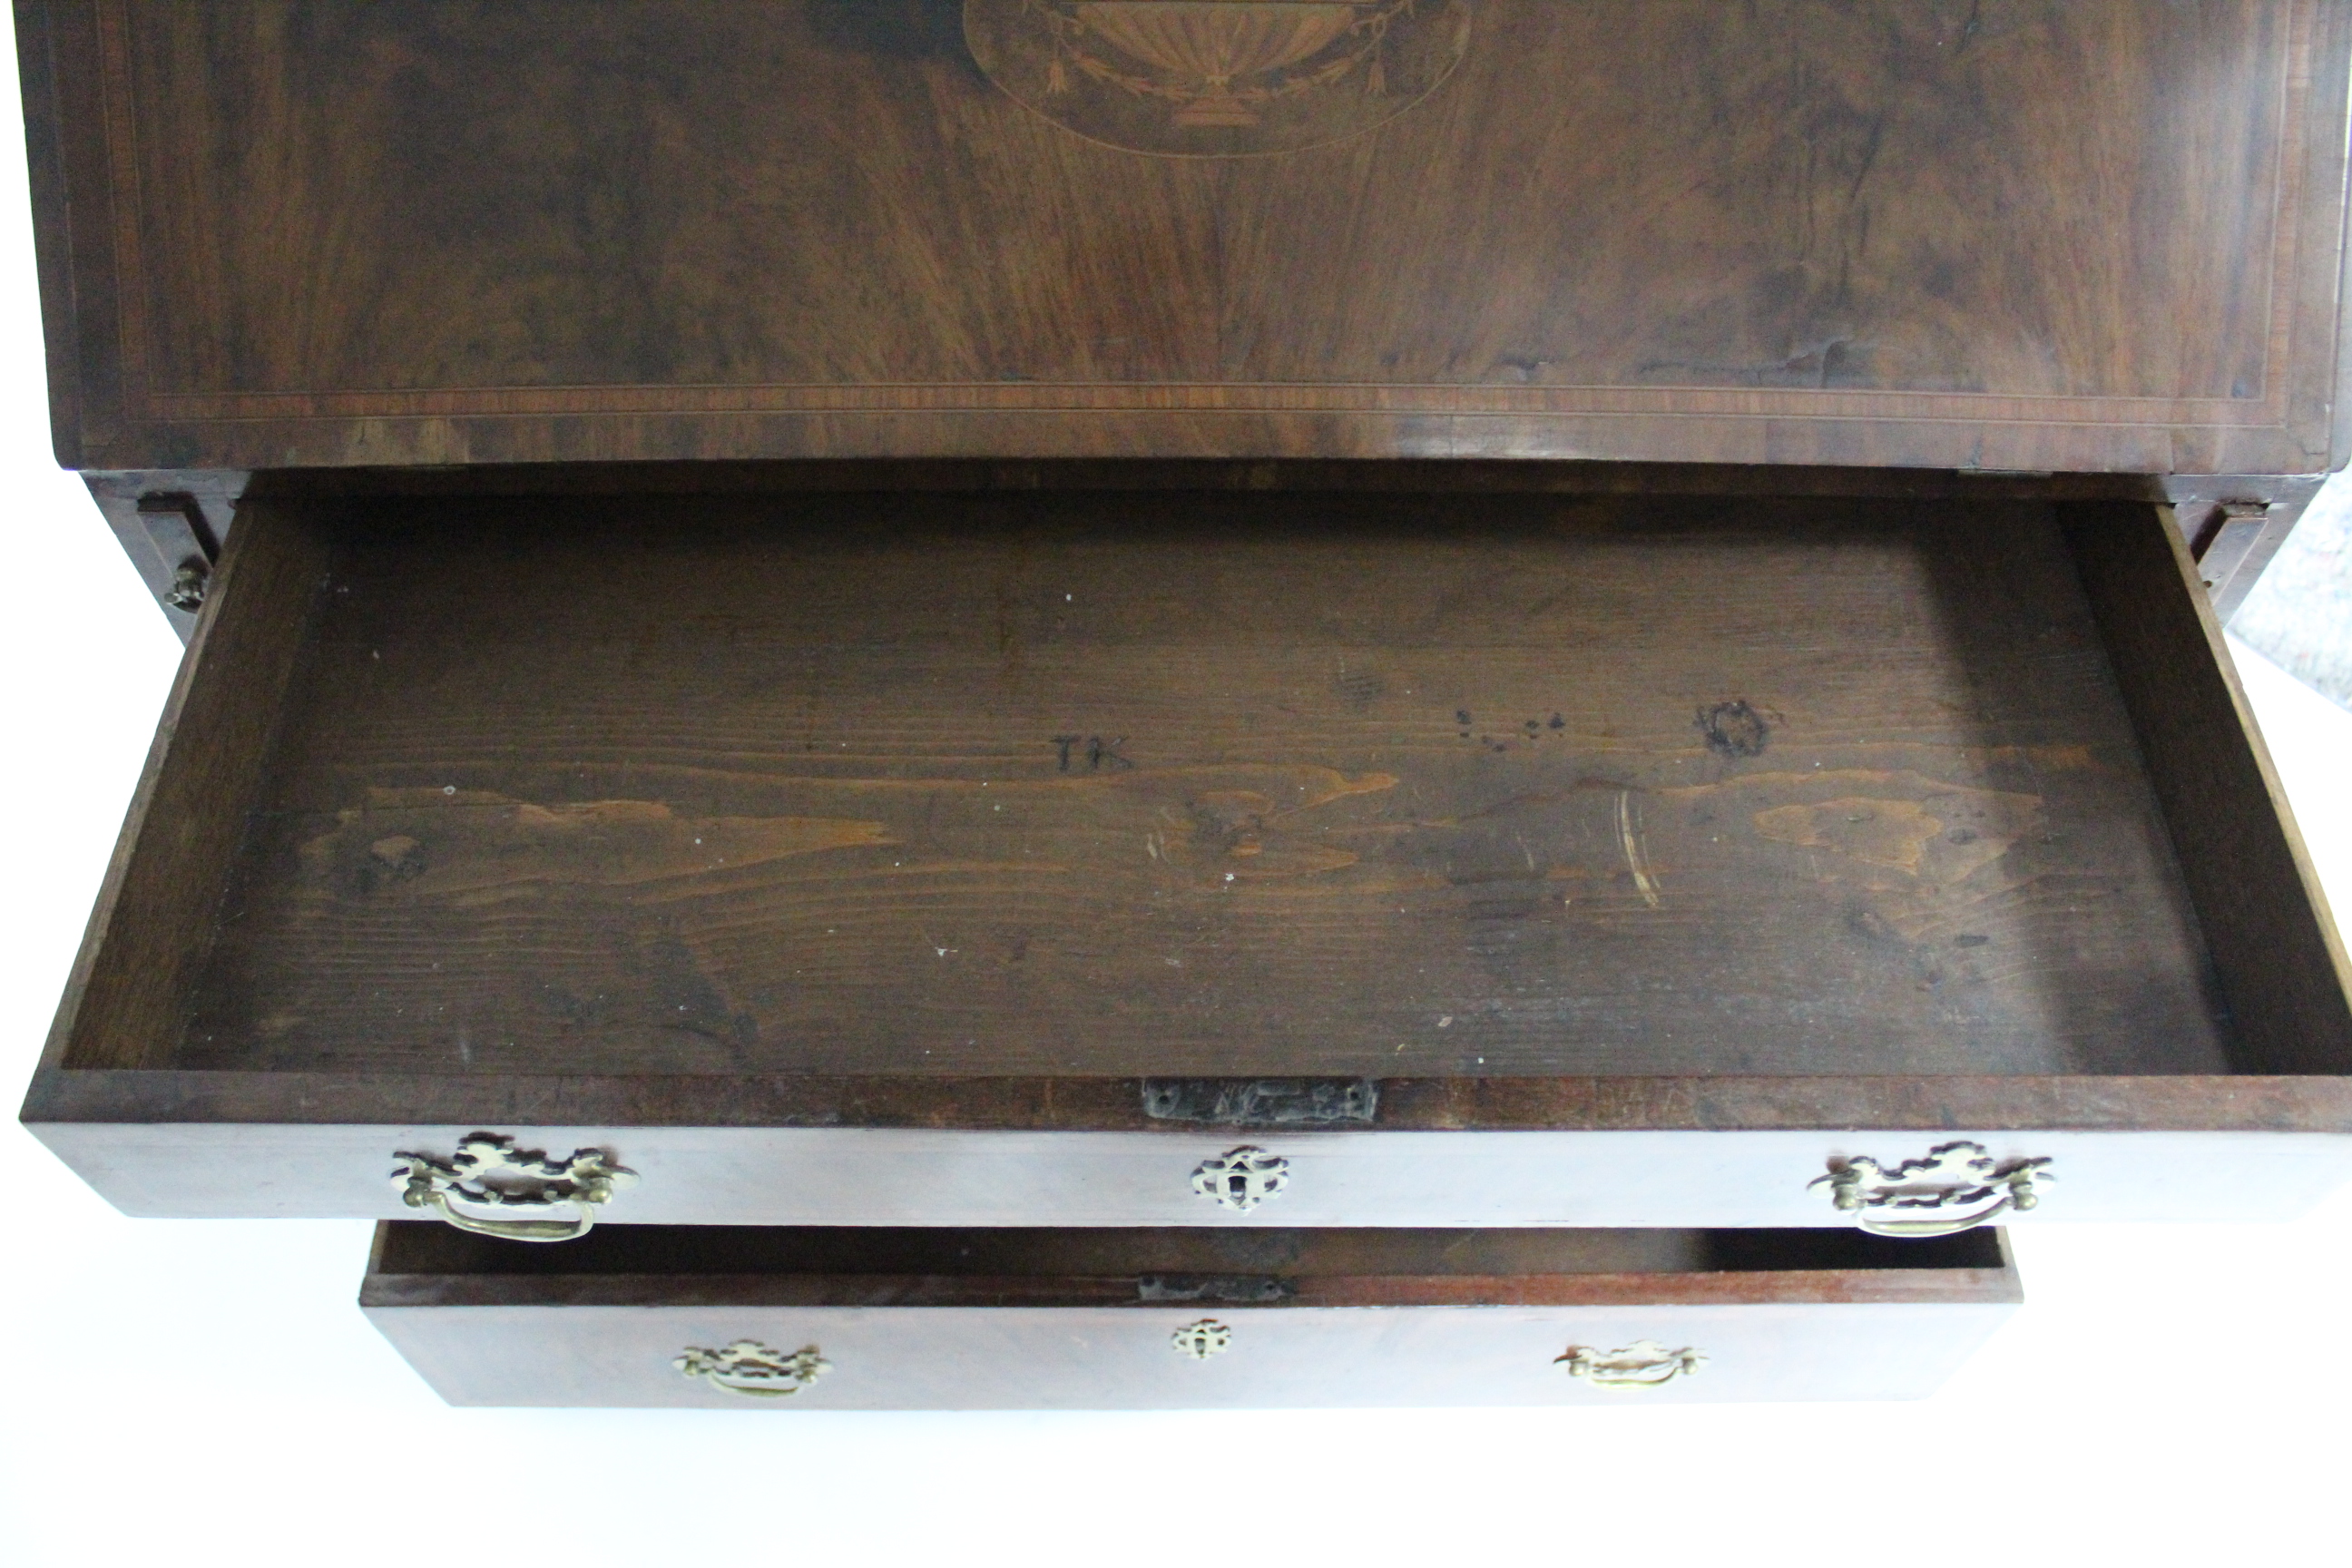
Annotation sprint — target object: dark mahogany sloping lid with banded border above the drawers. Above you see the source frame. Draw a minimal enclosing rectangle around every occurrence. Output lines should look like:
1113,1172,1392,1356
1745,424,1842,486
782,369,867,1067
19,0,2352,473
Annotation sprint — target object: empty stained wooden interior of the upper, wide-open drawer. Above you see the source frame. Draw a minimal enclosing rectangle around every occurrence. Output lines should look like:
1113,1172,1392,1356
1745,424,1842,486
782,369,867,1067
52,491,2352,1100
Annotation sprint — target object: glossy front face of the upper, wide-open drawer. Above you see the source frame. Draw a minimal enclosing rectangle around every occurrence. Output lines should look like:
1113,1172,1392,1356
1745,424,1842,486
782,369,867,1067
35,1123,2352,1227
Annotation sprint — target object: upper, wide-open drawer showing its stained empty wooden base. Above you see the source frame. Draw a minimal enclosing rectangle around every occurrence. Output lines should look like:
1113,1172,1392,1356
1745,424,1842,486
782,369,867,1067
24,480,2352,1239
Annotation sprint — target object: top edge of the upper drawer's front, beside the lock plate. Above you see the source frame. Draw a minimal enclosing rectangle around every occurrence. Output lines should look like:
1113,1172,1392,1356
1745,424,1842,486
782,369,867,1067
24,1051,2352,1132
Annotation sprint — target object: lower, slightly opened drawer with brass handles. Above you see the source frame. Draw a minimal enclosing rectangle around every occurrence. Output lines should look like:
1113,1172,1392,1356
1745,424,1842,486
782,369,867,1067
360,1222,2018,1410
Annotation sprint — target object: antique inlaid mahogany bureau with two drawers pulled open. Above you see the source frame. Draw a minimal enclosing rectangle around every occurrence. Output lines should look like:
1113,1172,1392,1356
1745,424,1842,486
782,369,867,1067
16,0,2352,1404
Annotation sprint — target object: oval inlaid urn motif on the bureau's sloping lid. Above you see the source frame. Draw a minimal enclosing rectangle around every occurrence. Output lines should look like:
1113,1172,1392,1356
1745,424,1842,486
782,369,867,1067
965,0,1470,158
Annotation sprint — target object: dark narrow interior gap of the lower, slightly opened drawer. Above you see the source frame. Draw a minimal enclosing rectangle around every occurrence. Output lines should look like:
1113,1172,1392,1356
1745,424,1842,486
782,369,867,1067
362,1220,2015,1305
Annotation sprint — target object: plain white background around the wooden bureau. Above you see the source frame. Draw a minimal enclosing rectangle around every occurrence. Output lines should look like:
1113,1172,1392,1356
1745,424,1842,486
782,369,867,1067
0,30,2352,1568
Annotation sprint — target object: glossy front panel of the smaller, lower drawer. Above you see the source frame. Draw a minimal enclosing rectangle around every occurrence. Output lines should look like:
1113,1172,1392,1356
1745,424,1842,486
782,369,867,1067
369,1302,2014,1410
